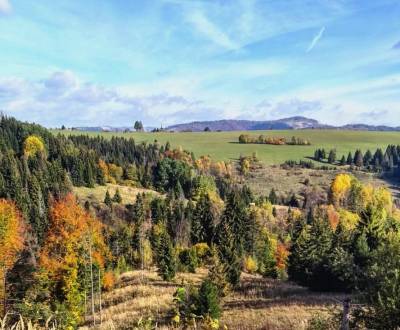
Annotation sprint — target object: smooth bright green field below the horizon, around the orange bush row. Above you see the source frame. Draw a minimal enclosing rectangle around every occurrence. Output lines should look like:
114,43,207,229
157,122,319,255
53,130,400,164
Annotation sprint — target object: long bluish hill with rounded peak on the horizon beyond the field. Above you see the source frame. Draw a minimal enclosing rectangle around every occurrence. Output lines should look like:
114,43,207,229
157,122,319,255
167,116,333,132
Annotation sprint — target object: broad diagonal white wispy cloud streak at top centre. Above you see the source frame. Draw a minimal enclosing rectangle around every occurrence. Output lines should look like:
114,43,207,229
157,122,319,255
188,10,239,49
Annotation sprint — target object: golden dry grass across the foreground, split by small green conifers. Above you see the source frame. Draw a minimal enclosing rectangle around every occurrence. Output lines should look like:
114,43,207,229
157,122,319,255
79,269,344,330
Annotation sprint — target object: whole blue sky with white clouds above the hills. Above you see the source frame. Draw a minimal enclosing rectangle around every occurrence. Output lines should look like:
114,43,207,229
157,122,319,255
0,0,400,127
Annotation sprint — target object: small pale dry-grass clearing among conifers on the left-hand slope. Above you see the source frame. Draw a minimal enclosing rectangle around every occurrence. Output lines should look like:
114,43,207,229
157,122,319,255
73,183,158,204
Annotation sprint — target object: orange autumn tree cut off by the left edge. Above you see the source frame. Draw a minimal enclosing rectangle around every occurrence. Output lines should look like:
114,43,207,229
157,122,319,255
0,199,24,316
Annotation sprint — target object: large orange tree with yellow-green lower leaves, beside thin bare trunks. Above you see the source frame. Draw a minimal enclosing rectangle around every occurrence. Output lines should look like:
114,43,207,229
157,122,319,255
38,194,109,328
